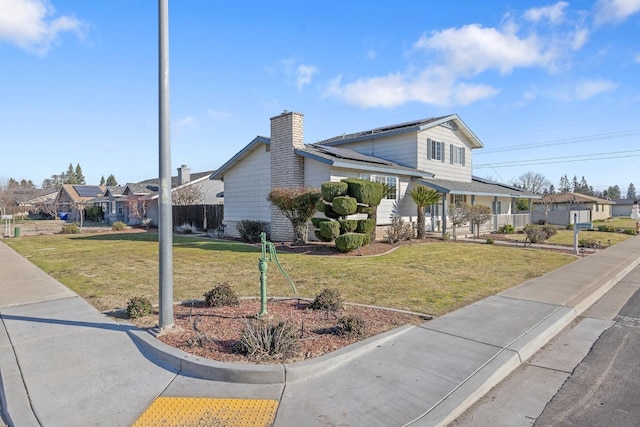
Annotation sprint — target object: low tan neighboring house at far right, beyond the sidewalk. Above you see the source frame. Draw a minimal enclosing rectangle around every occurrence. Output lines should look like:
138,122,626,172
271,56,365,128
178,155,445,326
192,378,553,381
533,192,616,225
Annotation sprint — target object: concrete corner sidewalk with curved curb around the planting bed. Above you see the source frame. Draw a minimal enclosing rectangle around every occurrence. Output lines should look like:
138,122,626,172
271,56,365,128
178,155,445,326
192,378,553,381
0,238,640,427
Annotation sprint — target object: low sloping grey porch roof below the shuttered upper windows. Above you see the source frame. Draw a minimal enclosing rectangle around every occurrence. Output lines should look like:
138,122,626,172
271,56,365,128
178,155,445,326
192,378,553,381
414,176,542,199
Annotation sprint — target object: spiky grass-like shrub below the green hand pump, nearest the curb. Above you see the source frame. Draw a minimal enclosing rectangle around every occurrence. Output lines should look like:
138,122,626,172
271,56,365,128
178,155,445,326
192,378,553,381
236,319,300,361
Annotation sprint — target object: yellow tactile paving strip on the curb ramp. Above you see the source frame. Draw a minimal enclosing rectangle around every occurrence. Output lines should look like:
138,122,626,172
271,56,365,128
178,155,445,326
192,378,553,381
132,397,278,427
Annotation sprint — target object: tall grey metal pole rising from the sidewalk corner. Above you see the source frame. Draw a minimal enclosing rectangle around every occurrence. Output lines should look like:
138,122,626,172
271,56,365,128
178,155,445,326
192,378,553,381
158,0,174,331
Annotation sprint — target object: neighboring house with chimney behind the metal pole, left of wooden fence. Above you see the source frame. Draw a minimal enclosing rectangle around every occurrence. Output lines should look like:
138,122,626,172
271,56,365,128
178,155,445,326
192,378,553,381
114,165,224,226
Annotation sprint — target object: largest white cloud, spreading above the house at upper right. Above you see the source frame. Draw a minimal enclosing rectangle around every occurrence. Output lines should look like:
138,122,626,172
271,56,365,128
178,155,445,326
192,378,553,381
324,0,596,107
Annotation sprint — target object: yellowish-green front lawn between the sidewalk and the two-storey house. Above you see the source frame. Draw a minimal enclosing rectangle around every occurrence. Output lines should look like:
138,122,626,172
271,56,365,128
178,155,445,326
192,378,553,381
4,233,576,315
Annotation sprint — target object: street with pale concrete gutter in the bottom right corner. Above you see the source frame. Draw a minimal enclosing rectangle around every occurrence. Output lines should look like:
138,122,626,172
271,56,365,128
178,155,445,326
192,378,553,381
452,268,640,427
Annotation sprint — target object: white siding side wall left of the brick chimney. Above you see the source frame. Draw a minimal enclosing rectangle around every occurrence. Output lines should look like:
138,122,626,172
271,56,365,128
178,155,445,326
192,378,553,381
224,144,271,224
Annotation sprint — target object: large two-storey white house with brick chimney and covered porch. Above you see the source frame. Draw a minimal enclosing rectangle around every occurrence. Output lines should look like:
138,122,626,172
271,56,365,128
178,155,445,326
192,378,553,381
211,111,541,241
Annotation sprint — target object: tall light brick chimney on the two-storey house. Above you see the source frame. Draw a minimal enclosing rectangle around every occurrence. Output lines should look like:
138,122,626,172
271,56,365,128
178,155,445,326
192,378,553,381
270,111,304,241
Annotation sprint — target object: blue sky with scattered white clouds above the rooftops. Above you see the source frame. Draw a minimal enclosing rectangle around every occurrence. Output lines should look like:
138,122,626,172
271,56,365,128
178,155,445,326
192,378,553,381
0,0,640,194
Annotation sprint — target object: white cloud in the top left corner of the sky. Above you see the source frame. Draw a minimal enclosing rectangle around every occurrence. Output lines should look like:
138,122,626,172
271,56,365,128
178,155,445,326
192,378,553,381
0,0,86,55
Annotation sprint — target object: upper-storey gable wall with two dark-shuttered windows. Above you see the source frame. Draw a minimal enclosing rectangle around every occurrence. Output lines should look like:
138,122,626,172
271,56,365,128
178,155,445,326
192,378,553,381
416,126,472,182
